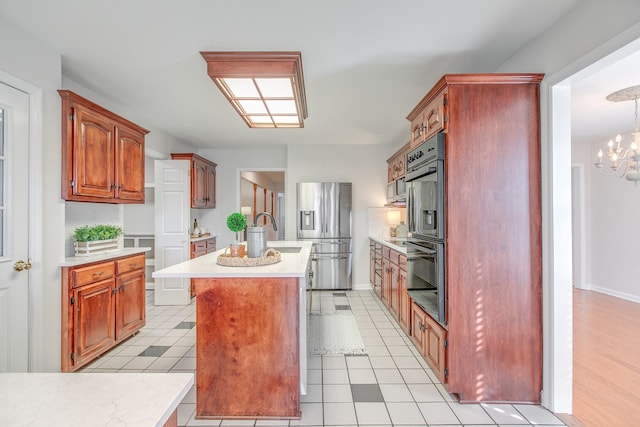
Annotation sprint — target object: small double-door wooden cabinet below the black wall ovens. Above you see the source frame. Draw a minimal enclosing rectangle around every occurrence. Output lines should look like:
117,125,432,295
411,302,447,384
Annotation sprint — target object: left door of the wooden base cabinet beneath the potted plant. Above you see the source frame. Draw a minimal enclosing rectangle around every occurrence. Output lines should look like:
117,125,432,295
72,278,116,366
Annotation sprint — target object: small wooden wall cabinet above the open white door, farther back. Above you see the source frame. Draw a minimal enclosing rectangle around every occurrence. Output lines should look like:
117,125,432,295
171,153,217,209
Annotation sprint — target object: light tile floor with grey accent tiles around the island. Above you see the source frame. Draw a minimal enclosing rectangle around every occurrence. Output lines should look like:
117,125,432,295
82,291,565,427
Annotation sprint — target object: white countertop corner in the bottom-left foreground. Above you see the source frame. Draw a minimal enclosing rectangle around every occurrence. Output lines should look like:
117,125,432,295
0,373,194,427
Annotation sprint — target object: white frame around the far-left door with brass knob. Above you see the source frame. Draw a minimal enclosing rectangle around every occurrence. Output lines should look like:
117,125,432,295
0,70,44,372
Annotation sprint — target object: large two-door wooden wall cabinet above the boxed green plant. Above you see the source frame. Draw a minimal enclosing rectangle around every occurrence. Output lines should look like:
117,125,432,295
58,90,149,203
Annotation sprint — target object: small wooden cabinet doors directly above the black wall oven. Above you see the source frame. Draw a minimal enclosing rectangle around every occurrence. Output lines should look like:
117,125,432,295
407,88,447,148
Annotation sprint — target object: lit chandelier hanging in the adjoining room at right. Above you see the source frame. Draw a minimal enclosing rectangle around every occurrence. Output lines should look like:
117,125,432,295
594,85,640,185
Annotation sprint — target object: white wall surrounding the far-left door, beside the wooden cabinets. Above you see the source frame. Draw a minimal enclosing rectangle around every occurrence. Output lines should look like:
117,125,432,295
0,18,64,371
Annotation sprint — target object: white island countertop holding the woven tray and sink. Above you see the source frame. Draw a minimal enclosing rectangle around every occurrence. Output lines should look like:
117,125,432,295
152,240,312,278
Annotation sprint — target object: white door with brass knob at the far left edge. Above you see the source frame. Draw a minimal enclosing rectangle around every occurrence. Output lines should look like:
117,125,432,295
0,83,31,372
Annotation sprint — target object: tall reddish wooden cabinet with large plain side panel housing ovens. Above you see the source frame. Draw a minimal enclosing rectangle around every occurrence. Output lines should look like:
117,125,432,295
407,74,543,403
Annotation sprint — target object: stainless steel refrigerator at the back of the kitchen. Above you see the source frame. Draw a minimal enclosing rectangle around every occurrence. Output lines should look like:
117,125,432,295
296,182,352,290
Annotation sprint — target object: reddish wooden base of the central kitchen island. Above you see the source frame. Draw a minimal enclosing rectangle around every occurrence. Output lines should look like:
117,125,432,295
195,277,300,419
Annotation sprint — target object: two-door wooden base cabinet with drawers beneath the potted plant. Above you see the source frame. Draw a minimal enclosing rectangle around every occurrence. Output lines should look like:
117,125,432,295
61,253,146,372
